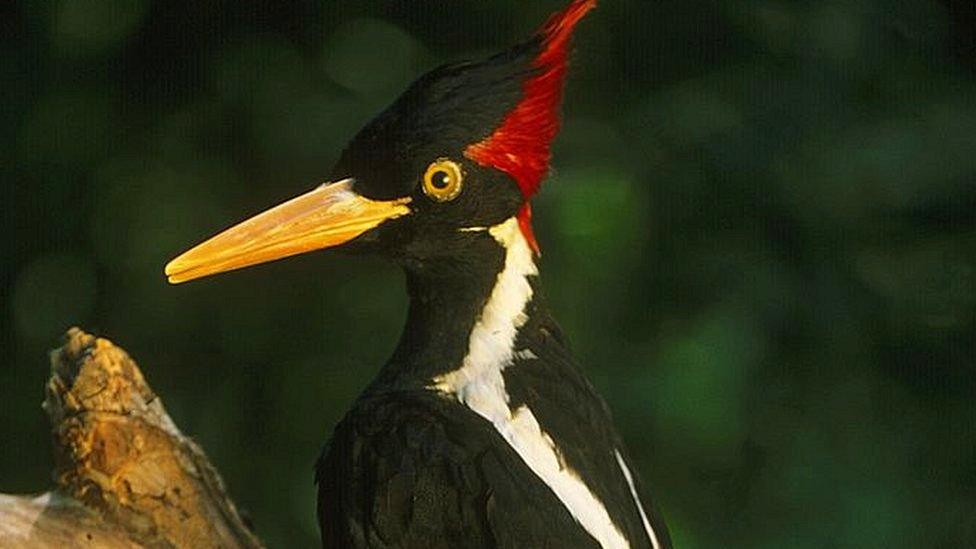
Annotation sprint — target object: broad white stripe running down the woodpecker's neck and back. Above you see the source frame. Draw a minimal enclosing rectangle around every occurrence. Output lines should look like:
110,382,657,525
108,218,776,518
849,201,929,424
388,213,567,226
432,218,630,549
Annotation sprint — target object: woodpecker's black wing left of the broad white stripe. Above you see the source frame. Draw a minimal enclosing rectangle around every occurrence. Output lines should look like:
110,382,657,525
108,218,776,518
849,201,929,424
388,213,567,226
317,392,597,548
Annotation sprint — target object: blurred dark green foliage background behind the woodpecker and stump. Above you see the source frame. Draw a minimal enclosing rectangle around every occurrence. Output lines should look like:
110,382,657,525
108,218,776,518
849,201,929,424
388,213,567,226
0,0,976,548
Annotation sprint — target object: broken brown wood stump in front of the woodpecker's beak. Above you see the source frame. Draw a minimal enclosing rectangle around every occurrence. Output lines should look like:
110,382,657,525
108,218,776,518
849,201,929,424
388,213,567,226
0,329,261,549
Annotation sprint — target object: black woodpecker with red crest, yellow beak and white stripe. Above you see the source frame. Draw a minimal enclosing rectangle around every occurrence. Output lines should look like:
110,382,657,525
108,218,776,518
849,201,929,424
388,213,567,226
166,0,670,549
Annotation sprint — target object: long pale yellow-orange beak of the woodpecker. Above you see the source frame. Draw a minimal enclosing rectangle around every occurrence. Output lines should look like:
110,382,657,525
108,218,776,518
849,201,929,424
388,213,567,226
166,179,410,284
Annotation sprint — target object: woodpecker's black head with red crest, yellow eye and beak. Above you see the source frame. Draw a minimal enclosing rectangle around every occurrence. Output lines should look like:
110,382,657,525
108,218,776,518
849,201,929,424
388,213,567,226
166,0,596,283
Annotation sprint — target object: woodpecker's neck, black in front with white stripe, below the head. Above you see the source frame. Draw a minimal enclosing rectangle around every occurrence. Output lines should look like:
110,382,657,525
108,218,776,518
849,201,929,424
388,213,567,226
384,218,541,383
